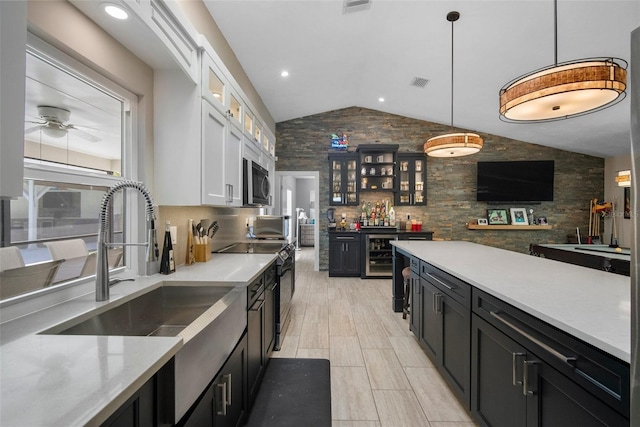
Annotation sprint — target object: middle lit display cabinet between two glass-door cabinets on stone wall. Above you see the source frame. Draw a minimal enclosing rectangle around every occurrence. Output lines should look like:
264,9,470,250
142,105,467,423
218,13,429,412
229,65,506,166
358,144,398,191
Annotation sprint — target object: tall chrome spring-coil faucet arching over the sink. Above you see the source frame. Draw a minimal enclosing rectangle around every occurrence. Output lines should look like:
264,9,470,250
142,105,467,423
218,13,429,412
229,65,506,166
96,181,158,301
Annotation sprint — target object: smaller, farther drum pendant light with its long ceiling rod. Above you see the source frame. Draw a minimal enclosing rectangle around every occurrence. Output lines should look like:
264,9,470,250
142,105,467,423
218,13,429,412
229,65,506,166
424,11,483,157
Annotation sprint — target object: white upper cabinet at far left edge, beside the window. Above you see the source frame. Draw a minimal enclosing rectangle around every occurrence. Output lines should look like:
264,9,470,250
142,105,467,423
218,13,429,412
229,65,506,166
0,1,27,198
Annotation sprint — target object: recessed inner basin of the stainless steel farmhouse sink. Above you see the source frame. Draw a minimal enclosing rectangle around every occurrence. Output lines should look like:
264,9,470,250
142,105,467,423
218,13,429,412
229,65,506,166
45,285,234,337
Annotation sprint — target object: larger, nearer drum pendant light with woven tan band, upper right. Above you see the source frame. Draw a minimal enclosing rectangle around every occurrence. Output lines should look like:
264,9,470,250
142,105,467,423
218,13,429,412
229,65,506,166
500,0,627,123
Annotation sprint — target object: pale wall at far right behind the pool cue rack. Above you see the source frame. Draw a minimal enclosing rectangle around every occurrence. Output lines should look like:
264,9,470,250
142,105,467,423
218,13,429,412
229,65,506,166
602,155,634,248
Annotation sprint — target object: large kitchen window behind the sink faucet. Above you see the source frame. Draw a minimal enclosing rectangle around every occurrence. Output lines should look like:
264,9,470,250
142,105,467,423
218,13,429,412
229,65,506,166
2,34,139,300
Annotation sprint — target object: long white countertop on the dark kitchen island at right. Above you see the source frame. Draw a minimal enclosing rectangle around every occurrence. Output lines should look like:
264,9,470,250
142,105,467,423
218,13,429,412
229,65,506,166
392,241,631,363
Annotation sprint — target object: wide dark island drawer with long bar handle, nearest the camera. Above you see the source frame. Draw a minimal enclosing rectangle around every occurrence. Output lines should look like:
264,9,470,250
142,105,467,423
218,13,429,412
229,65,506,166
472,289,630,418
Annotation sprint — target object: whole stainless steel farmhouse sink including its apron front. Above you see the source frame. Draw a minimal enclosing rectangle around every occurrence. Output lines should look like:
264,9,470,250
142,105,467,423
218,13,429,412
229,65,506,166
41,281,247,423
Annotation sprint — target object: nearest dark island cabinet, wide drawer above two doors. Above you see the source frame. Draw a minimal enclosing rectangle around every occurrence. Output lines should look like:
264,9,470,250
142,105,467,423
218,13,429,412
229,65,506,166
471,290,629,427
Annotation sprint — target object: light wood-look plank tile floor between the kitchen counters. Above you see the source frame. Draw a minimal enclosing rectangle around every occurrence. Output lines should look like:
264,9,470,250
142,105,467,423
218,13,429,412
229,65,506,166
272,248,476,427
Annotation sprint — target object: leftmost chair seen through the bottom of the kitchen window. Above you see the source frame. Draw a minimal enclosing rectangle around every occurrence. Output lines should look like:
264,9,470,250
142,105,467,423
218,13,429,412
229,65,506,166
0,246,62,299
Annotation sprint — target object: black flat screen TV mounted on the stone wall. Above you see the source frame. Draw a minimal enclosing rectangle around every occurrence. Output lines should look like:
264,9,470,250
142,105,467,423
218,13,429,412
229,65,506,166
477,160,554,202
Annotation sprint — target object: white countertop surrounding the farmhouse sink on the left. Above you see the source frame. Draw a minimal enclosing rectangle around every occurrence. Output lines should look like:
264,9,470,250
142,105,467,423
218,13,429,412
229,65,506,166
0,254,277,427
